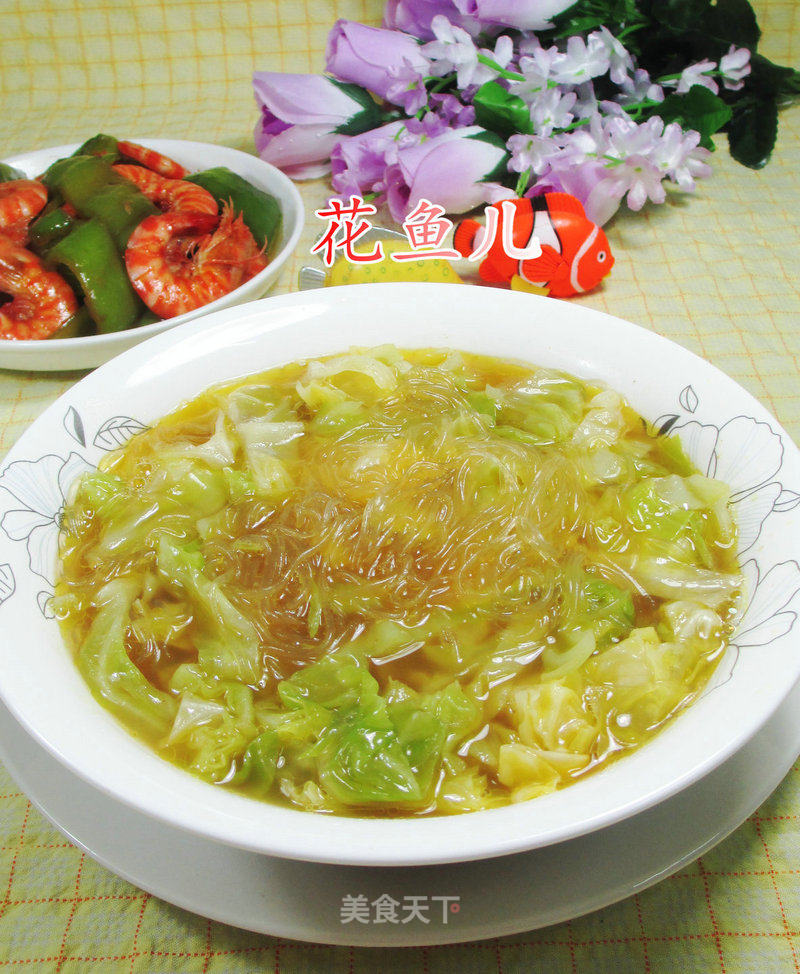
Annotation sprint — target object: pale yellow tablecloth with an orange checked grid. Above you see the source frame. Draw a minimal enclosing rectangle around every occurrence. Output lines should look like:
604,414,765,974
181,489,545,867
0,0,800,974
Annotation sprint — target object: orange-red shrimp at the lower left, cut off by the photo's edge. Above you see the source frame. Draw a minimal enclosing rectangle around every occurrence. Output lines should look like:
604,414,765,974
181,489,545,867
0,233,78,339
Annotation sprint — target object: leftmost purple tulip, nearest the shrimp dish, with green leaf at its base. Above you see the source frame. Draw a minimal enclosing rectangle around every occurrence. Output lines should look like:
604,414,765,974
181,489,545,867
253,71,383,179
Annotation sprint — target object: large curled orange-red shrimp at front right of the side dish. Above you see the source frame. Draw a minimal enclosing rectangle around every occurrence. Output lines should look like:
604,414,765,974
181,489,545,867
125,210,254,318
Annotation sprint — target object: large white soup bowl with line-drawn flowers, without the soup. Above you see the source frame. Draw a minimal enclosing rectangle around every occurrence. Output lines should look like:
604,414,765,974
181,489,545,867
0,284,800,865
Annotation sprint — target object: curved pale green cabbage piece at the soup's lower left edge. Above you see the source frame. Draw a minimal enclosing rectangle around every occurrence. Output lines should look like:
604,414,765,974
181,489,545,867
78,578,177,735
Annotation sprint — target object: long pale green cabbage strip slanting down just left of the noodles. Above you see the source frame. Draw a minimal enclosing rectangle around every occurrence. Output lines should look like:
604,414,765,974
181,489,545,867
157,535,263,685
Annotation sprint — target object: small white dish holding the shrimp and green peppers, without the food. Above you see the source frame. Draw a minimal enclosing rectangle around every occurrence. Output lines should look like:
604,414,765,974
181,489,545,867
0,139,304,372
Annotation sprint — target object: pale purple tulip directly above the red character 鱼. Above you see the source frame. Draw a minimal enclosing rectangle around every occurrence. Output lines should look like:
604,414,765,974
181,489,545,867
385,125,514,223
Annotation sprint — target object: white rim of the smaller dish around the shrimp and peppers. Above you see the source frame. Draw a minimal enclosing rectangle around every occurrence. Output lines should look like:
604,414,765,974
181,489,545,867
1,137,305,367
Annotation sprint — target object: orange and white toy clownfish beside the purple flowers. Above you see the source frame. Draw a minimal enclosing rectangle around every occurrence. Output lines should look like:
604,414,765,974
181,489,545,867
453,193,614,298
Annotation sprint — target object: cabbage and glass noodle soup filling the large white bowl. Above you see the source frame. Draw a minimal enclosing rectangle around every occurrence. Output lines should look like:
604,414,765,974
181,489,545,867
56,346,740,815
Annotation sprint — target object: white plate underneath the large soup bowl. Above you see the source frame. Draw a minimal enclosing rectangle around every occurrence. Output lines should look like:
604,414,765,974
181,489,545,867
0,672,800,947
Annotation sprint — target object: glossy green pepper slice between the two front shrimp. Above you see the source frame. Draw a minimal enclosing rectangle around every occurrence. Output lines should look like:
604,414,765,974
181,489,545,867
46,220,142,334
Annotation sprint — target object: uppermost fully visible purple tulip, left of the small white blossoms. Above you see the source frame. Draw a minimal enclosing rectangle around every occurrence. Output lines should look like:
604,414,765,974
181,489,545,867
325,20,430,115
